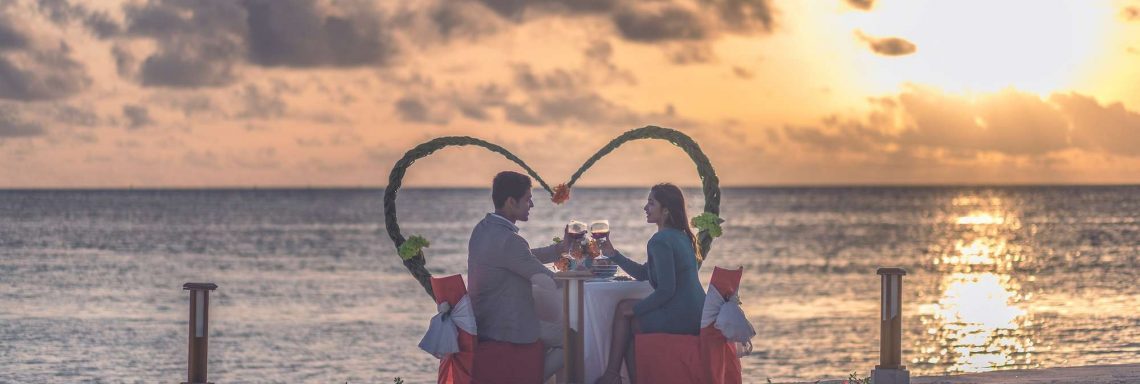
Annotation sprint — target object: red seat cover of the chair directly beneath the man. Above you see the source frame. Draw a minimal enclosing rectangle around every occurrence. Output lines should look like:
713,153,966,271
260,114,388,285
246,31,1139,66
474,340,546,384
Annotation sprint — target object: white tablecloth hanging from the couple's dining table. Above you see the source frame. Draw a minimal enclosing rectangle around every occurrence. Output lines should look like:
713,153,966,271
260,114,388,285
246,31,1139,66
583,281,653,383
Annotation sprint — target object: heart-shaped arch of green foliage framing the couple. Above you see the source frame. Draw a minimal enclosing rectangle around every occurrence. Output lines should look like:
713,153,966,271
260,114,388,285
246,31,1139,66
384,125,720,296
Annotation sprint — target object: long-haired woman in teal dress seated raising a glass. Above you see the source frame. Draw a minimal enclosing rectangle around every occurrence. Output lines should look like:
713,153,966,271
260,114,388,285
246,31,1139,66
596,183,705,384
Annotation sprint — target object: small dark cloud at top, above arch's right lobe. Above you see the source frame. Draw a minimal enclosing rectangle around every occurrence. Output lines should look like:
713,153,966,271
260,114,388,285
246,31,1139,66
613,3,708,42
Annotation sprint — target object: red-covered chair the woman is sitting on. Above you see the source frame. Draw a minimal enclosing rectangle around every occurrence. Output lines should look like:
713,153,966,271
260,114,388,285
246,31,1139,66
634,267,743,384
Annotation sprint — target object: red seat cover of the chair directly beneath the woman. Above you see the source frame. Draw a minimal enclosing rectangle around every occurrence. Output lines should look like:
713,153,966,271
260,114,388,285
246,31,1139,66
634,334,707,384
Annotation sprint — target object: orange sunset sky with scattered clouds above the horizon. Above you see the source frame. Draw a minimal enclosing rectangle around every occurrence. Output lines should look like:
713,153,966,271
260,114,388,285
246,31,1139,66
0,0,1140,188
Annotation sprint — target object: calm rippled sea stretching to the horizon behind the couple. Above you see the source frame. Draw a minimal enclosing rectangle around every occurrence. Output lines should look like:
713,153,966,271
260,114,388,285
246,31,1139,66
0,187,1140,383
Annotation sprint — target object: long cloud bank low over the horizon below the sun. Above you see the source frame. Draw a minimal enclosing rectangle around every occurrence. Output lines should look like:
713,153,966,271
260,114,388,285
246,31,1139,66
783,87,1140,158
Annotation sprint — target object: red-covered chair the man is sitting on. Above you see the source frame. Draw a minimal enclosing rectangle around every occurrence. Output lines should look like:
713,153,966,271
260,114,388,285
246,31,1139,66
431,275,545,384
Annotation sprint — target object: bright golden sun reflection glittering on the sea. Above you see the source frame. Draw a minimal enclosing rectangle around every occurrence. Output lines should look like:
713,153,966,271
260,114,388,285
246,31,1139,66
911,192,1039,373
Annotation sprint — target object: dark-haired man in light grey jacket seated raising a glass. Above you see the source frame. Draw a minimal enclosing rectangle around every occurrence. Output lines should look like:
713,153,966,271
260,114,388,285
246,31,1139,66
467,171,569,379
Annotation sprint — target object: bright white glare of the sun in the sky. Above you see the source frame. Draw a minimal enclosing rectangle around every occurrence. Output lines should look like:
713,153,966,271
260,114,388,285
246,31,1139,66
846,0,1116,96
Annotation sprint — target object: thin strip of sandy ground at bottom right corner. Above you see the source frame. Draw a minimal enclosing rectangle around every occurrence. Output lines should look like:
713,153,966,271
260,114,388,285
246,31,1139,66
802,363,1140,384
